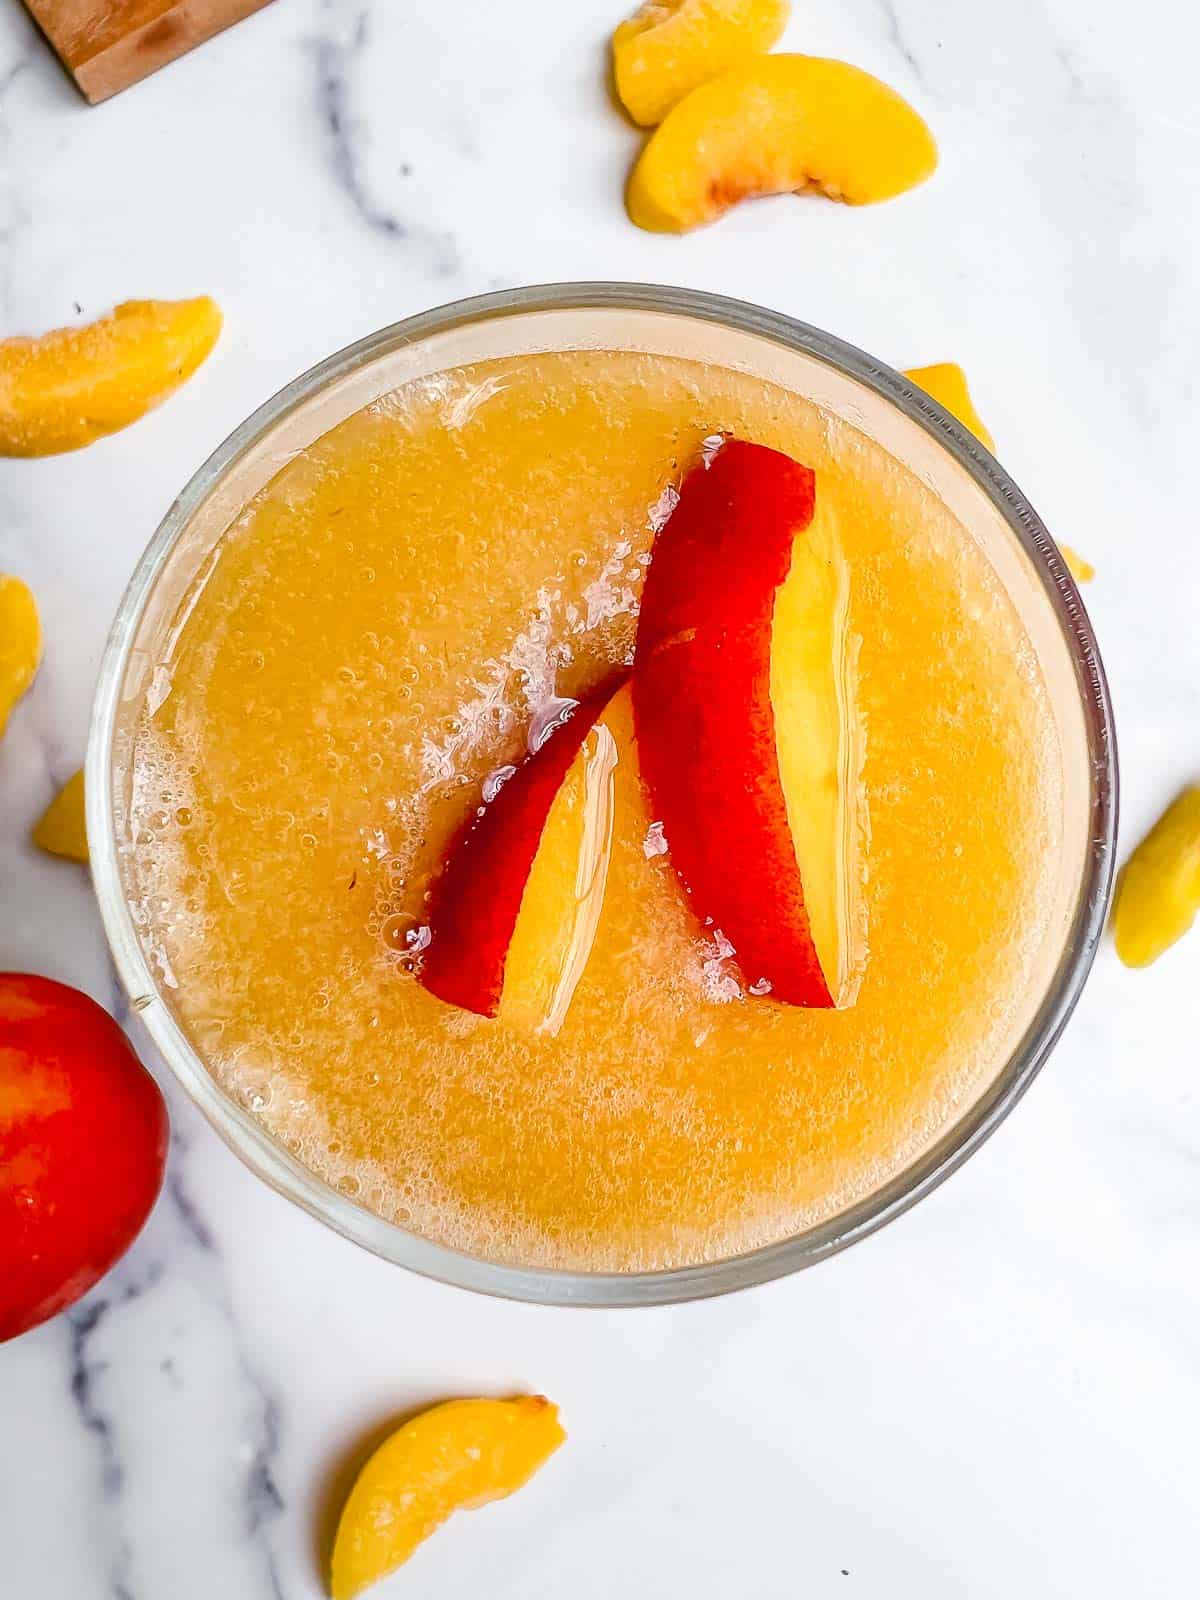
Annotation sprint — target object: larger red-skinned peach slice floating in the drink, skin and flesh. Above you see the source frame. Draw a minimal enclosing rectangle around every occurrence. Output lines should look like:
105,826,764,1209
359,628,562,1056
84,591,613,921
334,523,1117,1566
634,440,866,1006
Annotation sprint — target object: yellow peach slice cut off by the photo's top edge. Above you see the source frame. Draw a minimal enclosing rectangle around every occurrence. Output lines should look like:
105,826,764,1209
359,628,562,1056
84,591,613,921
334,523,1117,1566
613,0,792,126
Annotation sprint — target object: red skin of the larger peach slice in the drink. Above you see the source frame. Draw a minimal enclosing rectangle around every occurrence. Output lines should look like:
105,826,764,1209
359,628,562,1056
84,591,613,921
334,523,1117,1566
634,440,834,1006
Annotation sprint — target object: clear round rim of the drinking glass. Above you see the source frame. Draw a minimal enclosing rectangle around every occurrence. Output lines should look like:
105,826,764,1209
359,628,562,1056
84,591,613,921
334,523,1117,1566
85,282,1118,1307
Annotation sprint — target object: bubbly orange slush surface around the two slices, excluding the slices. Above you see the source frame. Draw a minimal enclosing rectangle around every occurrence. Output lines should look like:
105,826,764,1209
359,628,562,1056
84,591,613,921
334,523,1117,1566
130,352,1062,1269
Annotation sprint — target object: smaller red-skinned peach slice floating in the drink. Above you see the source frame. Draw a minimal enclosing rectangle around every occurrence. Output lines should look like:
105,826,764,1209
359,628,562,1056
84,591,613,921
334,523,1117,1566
419,682,630,1032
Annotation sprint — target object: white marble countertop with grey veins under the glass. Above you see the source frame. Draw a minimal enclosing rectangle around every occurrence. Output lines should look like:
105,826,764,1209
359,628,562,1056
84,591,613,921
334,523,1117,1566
0,0,1200,1600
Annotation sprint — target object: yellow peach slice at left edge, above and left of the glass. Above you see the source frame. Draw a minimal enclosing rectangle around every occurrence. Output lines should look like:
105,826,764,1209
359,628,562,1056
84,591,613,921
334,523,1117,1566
0,296,221,456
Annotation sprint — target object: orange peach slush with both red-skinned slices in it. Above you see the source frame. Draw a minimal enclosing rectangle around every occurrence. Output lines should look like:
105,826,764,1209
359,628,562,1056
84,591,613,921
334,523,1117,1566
131,350,1062,1270
